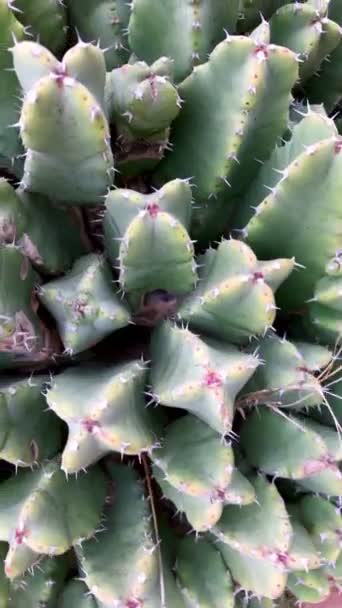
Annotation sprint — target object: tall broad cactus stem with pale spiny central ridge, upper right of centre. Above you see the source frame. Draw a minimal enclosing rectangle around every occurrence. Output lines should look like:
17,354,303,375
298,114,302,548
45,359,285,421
157,36,298,242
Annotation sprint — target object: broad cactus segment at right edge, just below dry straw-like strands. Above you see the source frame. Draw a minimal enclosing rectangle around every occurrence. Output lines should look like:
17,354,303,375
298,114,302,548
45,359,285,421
241,408,342,480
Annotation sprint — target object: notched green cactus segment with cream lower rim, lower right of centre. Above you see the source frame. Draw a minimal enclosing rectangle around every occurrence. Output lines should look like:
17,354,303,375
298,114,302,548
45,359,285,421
213,477,292,563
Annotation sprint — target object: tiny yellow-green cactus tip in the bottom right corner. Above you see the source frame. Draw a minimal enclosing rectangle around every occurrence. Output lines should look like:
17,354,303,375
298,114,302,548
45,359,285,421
287,569,330,604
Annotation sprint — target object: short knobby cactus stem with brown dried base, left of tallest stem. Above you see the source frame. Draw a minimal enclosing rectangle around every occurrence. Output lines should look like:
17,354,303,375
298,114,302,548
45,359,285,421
106,57,181,175
